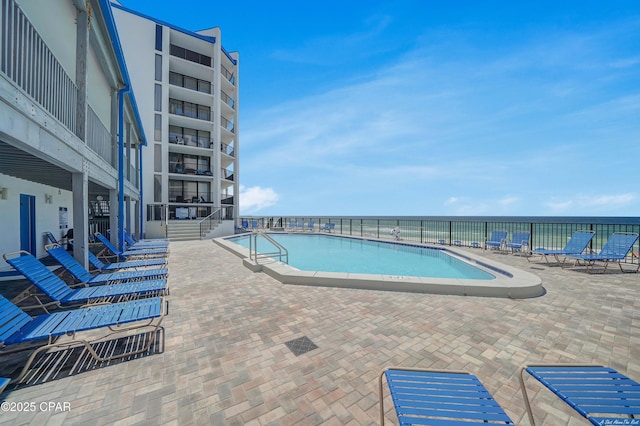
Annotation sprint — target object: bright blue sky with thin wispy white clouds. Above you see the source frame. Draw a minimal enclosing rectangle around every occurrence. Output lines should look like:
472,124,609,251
121,0,640,216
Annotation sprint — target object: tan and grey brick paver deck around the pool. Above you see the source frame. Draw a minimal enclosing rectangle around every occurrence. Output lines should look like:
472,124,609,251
0,240,640,425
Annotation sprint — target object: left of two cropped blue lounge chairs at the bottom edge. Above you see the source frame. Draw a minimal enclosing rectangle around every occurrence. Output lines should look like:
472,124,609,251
378,367,515,425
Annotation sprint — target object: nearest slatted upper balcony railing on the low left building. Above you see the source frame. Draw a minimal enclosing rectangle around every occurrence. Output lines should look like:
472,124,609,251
0,0,78,134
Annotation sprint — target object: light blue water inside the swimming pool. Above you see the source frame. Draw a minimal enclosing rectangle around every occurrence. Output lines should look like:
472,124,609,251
229,234,495,280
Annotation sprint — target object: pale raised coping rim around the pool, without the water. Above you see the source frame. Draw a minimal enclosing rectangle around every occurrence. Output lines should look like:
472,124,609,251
213,232,545,299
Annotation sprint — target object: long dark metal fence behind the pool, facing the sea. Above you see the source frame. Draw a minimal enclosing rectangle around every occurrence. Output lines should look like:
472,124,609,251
239,216,640,261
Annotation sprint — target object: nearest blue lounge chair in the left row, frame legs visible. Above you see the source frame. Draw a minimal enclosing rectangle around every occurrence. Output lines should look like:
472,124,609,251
0,296,166,382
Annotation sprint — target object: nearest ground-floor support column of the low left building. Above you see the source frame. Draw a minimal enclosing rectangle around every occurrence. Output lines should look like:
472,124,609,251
71,166,89,268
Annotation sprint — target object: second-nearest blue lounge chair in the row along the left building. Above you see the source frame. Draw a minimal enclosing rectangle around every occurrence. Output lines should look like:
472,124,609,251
3,251,167,312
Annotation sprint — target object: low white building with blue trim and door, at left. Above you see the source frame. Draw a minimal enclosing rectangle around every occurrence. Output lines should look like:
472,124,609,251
0,0,146,275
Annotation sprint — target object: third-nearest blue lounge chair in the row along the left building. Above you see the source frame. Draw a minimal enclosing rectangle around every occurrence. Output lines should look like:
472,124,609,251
45,246,169,285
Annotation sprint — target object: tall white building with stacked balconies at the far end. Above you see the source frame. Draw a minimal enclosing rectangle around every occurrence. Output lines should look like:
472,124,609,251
112,3,239,238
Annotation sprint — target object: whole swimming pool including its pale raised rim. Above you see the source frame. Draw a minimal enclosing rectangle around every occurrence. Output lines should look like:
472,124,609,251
213,232,545,299
